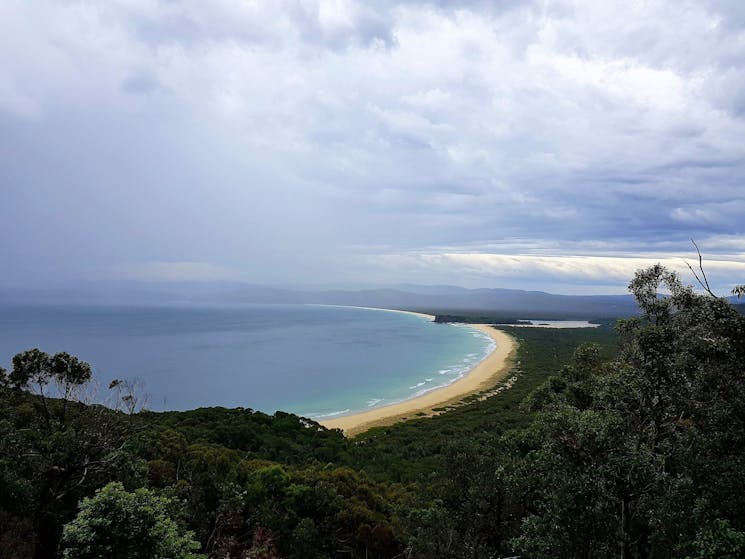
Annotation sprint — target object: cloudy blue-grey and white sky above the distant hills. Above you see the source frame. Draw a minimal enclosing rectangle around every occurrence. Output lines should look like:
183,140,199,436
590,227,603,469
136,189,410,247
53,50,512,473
0,0,745,294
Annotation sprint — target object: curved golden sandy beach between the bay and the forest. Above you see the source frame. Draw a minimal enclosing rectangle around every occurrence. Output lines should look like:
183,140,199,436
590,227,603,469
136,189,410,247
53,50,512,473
319,320,517,436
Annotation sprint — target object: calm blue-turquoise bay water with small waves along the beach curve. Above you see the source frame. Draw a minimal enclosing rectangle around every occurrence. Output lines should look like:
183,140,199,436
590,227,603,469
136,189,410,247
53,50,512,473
0,305,493,418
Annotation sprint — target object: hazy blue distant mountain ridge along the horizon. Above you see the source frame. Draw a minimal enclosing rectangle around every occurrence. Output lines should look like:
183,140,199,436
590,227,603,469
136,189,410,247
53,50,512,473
0,282,637,319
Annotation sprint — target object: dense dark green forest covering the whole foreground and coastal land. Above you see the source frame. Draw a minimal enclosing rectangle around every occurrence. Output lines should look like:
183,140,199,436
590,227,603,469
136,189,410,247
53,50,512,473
0,266,745,559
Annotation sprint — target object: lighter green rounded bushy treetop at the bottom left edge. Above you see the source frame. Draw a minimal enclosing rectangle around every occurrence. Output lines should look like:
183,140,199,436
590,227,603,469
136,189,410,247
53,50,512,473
62,483,203,559
